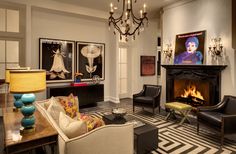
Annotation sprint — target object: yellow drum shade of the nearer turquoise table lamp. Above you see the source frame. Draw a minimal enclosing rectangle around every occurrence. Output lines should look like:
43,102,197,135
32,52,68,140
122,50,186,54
10,70,46,93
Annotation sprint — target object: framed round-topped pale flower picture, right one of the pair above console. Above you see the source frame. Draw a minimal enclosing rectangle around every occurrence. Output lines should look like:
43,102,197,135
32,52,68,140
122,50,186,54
76,41,105,81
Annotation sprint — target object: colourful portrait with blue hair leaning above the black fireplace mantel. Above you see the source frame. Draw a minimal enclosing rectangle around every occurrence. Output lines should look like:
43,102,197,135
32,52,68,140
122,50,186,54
174,31,206,65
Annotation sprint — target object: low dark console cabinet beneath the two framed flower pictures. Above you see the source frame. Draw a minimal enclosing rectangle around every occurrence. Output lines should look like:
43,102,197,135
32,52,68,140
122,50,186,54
47,84,104,106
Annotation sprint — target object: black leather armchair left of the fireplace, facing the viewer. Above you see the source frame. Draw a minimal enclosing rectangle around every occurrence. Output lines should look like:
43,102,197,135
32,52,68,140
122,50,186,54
133,84,161,114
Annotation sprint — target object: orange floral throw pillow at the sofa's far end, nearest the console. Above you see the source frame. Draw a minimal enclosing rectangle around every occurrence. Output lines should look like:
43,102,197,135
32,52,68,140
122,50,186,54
59,94,78,118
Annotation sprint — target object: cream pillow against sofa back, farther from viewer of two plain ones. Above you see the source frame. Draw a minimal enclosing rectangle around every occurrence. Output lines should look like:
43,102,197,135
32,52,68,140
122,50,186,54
47,97,65,124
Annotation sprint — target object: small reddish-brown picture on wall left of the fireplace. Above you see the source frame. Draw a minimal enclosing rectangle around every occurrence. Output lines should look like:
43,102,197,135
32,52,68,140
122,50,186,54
140,56,156,76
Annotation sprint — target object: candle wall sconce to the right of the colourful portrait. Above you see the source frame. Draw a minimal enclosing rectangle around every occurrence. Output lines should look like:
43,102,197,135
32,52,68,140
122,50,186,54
209,37,223,59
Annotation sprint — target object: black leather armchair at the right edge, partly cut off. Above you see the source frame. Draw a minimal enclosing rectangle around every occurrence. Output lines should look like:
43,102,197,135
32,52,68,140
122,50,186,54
197,95,236,146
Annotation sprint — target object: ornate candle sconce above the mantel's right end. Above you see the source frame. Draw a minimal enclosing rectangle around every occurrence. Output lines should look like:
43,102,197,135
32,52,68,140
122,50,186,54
208,37,225,64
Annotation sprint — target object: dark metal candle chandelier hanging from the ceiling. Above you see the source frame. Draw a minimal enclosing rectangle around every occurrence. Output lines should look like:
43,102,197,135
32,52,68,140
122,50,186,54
109,0,148,41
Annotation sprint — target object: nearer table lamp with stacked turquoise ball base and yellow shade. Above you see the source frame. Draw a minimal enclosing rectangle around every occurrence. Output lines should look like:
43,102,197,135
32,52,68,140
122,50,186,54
10,70,46,134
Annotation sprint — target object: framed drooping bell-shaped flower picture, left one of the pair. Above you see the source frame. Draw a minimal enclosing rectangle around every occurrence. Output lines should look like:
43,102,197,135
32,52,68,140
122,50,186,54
39,38,75,83
